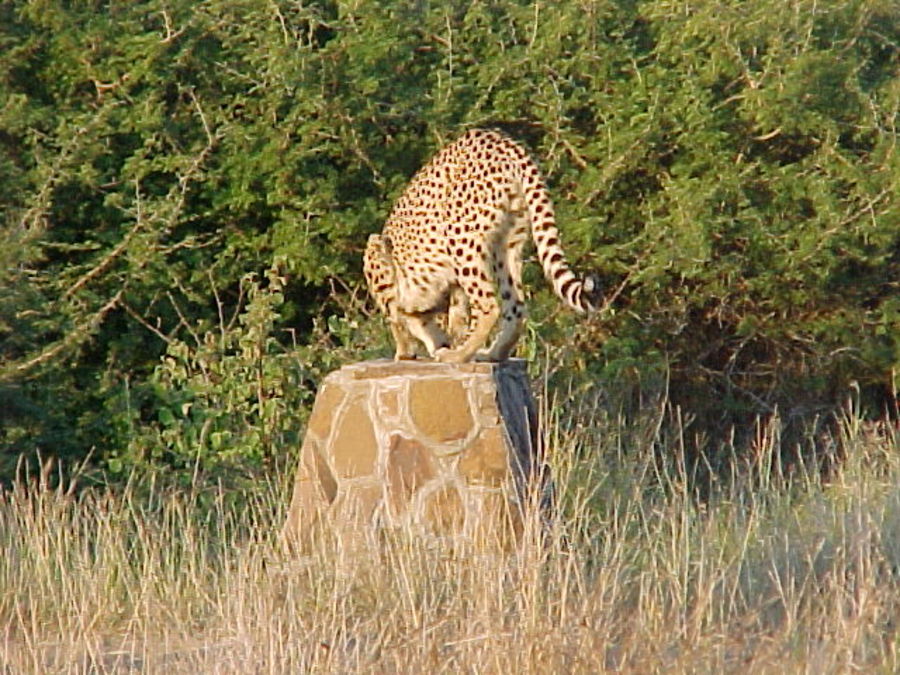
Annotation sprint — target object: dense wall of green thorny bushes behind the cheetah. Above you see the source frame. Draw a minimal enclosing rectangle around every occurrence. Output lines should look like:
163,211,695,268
0,0,900,486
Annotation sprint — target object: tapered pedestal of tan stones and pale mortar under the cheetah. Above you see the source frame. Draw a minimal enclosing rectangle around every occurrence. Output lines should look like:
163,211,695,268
283,359,543,548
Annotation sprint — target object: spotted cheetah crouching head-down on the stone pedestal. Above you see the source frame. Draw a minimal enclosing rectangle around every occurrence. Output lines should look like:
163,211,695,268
363,129,599,363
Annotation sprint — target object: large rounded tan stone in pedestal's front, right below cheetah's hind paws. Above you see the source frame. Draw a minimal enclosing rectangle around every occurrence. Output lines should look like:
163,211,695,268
409,379,472,443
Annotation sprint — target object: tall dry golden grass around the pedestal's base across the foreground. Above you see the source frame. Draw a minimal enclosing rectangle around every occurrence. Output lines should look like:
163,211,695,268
0,394,900,673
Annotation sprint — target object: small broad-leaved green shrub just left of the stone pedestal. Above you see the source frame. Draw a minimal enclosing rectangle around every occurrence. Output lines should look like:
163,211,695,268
109,271,309,484
